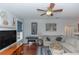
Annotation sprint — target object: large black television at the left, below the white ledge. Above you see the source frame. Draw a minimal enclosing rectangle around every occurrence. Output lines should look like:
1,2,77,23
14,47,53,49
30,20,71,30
0,30,16,50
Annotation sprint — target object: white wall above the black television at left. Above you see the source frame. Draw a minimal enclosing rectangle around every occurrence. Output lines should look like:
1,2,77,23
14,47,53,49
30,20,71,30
0,9,16,30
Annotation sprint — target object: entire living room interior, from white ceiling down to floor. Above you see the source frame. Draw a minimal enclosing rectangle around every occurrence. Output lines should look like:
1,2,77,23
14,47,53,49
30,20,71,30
0,3,79,55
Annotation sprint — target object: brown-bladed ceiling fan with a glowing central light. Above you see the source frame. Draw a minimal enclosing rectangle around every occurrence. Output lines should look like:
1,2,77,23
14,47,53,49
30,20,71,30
37,3,63,16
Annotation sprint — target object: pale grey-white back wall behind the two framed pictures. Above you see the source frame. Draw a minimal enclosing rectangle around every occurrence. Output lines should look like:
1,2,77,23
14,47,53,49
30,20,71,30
24,19,77,37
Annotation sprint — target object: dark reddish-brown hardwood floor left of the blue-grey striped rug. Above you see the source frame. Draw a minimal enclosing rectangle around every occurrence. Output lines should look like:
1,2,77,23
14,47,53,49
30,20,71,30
23,43,38,55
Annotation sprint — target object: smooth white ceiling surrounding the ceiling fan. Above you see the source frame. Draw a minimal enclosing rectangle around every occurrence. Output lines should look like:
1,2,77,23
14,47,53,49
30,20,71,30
0,3,79,19
